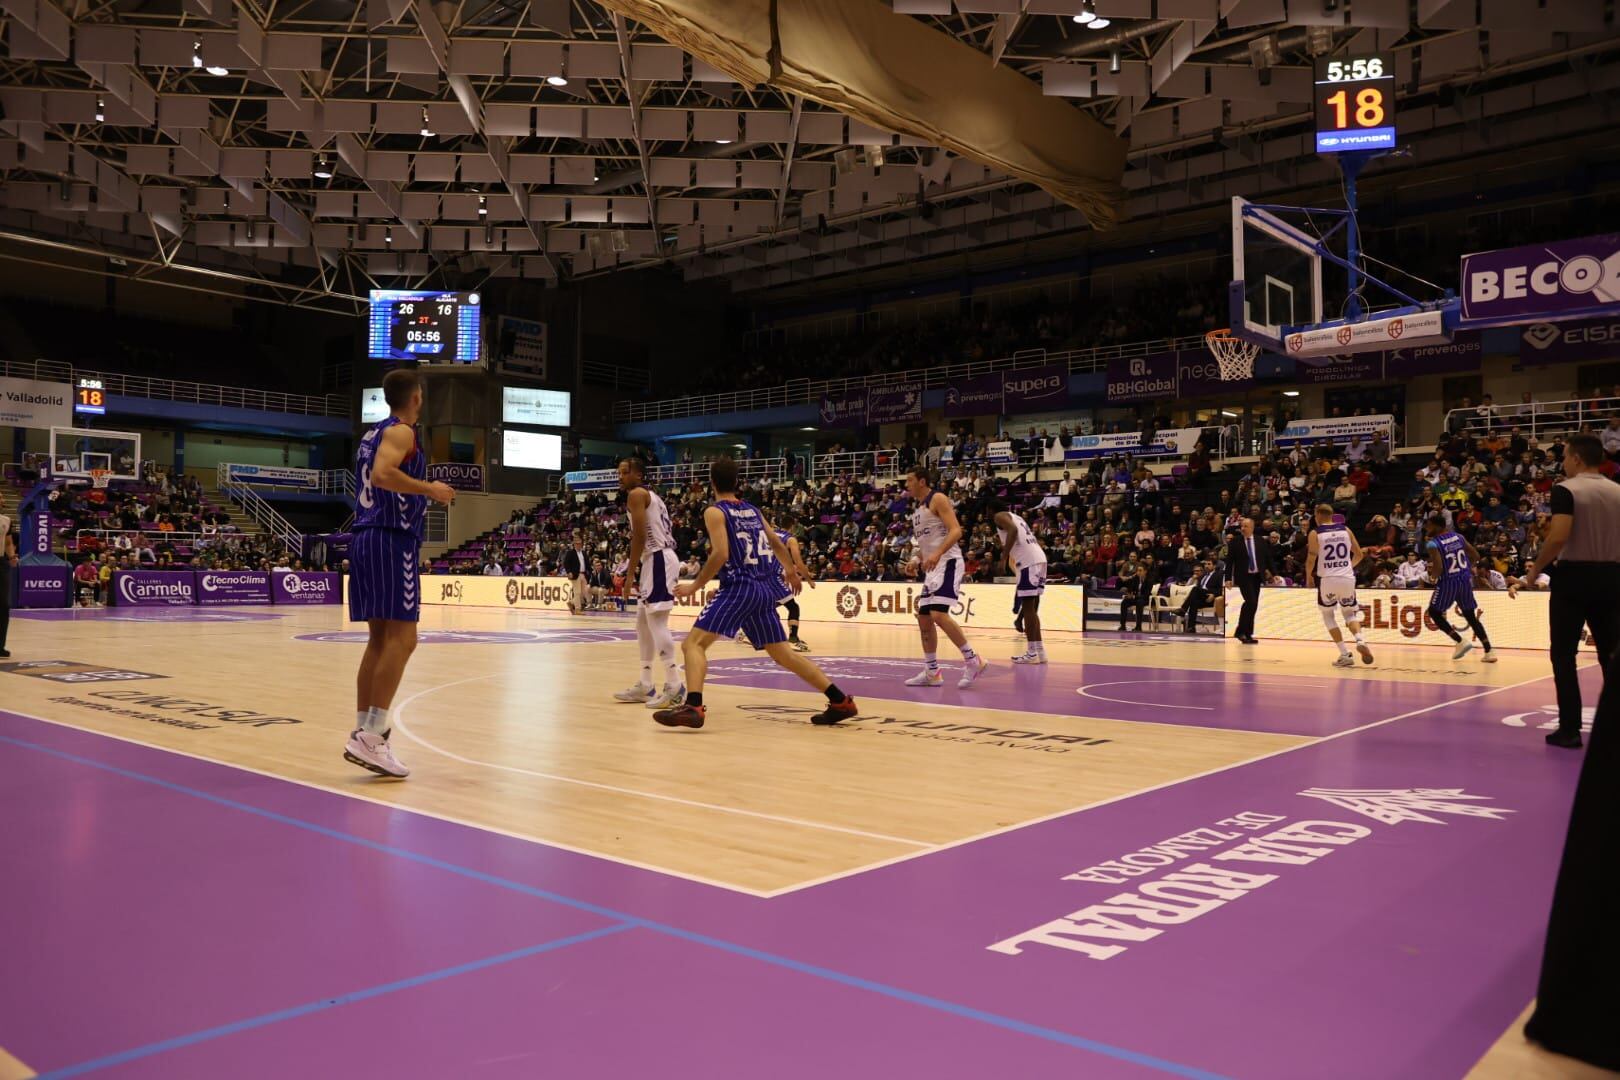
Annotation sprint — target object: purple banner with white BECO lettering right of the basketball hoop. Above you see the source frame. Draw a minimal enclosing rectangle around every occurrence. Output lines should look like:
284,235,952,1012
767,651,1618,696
1461,233,1620,322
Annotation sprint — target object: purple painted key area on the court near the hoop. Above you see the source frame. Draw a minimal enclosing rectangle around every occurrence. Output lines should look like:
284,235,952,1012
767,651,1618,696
708,656,1481,735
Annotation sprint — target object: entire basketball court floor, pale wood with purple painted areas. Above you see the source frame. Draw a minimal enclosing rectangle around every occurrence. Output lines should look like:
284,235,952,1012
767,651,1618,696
0,607,1597,1077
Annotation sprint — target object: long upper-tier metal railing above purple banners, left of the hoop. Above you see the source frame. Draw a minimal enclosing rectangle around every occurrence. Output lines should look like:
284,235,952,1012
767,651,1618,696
612,334,1204,423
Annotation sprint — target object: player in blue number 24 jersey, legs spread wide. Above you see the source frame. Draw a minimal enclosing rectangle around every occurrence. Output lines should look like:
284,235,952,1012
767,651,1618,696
653,458,857,727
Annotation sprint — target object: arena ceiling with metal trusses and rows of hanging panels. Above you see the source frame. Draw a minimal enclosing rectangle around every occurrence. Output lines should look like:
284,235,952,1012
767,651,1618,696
0,0,1620,306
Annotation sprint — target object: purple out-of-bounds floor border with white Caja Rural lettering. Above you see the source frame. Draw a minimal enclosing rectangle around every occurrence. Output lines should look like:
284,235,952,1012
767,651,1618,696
0,672,1597,1080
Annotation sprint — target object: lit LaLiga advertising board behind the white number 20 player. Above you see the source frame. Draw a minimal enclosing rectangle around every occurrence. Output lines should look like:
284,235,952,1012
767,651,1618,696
1218,588,1589,650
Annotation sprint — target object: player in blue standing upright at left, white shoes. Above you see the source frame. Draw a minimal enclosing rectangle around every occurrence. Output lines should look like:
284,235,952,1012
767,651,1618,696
343,369,455,777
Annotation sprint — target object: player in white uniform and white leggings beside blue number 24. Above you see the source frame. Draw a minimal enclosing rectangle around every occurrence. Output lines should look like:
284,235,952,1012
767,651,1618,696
614,457,687,709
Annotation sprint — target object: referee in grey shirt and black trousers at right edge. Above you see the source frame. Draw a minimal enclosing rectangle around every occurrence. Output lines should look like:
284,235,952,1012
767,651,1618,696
1529,436,1620,748
